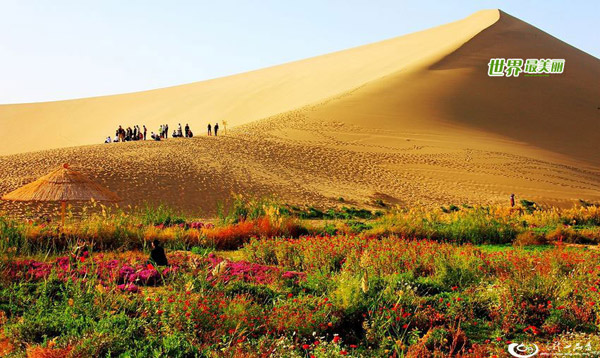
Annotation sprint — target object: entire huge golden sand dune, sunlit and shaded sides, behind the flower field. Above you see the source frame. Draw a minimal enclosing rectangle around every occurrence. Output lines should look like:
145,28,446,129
0,10,600,216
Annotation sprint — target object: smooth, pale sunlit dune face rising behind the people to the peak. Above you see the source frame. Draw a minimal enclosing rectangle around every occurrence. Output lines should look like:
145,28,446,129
0,11,498,155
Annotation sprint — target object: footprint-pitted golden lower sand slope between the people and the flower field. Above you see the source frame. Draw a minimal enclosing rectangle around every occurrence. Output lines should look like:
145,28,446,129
0,114,600,217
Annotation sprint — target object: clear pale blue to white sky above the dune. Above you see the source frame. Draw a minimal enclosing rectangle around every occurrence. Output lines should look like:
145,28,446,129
0,0,600,104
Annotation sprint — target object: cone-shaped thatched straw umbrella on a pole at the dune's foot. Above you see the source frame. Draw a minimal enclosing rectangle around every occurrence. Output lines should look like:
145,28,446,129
2,164,121,226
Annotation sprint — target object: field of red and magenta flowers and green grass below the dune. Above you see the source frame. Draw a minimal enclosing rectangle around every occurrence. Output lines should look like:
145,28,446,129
0,198,600,357
